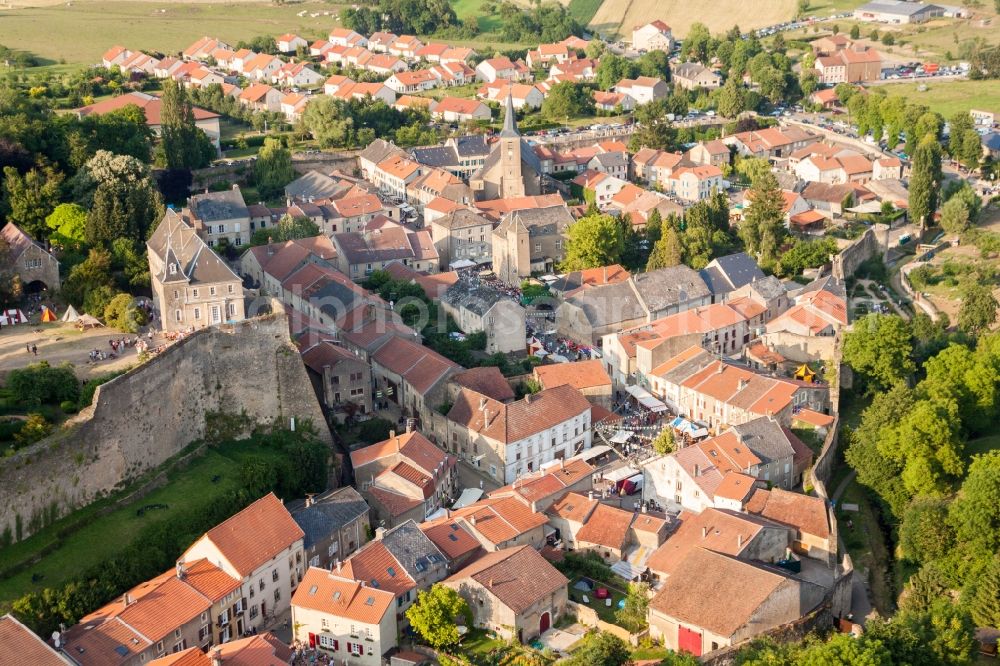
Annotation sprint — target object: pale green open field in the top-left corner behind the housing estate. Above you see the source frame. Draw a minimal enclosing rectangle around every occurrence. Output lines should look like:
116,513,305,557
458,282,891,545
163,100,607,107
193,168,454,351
0,0,348,64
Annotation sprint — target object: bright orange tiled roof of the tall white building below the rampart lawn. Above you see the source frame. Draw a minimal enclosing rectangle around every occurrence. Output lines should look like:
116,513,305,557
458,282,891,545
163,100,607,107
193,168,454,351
189,493,305,577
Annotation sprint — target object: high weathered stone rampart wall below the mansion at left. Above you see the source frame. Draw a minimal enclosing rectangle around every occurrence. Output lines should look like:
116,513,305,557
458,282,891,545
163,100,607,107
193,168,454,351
0,311,330,541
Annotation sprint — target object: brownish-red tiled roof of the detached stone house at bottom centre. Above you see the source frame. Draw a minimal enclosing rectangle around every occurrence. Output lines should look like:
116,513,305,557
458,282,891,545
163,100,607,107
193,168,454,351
447,546,569,614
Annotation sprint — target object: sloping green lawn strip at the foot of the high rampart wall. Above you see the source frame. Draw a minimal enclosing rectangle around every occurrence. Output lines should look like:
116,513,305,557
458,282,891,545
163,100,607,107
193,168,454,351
0,443,273,602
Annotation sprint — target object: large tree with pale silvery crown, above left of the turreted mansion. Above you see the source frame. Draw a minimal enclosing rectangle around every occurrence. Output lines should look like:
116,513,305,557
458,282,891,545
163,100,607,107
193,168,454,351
82,150,163,245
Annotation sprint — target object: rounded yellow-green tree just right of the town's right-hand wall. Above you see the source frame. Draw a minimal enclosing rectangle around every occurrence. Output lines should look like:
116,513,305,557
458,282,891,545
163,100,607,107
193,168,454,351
844,314,916,391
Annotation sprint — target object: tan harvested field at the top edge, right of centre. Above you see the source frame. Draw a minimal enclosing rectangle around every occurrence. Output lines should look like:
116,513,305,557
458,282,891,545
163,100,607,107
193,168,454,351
577,0,797,38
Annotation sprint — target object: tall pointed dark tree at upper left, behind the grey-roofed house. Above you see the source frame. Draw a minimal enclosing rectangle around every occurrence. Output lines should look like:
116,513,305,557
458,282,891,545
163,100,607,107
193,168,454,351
157,79,215,169
